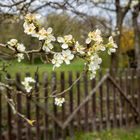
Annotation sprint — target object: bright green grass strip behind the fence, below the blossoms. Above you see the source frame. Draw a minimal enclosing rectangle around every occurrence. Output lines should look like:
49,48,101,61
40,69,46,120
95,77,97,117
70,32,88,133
0,60,84,75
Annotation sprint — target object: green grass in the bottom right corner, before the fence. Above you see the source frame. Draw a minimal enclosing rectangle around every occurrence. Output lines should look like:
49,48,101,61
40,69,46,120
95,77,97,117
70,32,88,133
67,126,140,140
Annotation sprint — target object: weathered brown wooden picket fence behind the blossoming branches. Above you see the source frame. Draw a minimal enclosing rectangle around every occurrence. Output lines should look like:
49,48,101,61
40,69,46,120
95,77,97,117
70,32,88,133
0,69,140,140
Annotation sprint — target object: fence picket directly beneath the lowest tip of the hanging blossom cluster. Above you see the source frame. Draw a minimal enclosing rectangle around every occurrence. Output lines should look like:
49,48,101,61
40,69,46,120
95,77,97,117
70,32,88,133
91,79,97,131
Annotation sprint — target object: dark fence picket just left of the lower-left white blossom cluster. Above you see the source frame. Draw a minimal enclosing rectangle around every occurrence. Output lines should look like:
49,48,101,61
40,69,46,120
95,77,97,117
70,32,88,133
16,73,22,140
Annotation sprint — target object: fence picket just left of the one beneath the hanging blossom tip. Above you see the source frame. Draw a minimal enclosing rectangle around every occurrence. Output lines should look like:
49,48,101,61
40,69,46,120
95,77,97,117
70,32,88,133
83,74,89,131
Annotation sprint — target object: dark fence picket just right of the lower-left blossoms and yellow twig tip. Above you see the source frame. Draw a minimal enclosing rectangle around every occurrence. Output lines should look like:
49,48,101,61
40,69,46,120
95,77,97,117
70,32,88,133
35,72,41,140
